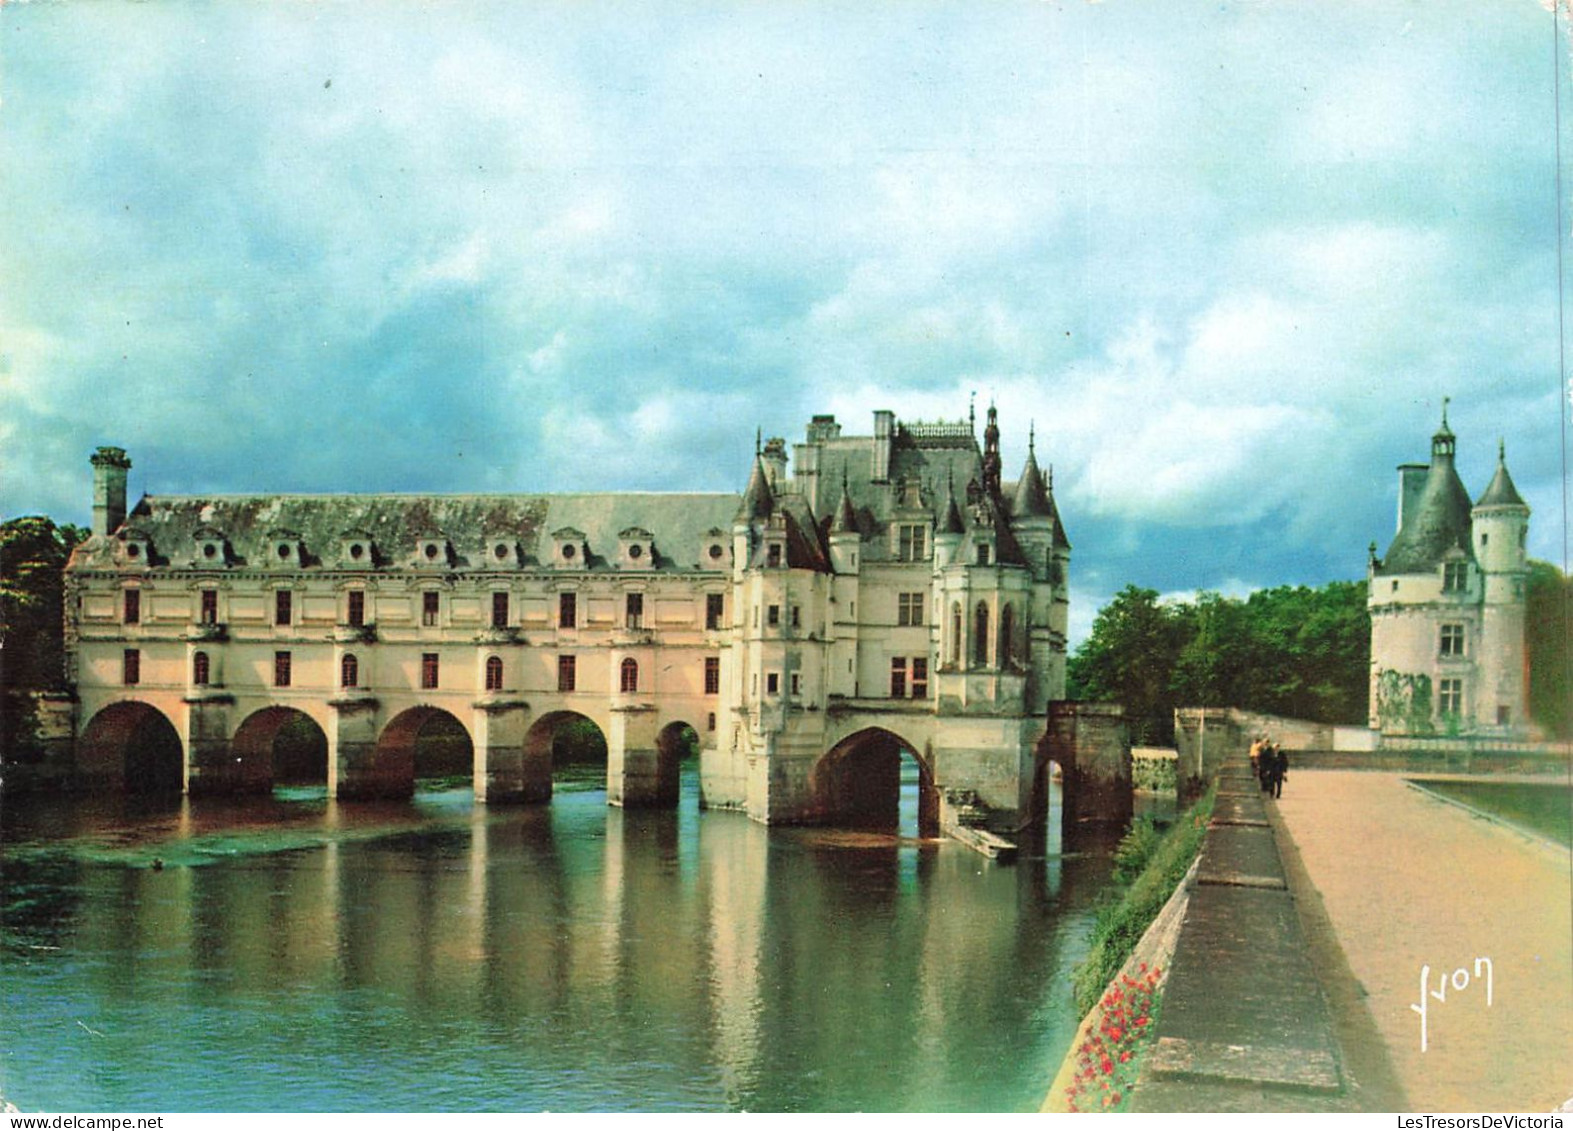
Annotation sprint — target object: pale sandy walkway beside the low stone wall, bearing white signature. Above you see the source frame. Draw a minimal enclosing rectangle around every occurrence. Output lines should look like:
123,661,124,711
1276,771,1573,1112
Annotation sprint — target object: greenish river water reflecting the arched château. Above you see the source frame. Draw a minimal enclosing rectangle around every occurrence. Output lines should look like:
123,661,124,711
0,772,1157,1112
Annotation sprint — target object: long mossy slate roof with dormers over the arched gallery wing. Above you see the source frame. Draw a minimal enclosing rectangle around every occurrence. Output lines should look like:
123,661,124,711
71,491,741,569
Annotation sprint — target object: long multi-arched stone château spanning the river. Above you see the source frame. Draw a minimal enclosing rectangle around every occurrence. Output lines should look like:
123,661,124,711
66,407,1070,832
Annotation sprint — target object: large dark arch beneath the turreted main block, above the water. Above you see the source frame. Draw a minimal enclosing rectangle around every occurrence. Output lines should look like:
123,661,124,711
809,727,939,837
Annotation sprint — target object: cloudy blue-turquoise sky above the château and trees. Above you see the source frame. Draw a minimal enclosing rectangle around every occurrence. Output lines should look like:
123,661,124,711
0,0,1573,642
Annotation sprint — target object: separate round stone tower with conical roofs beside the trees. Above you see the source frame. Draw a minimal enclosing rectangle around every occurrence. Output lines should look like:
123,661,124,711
1369,404,1529,738
